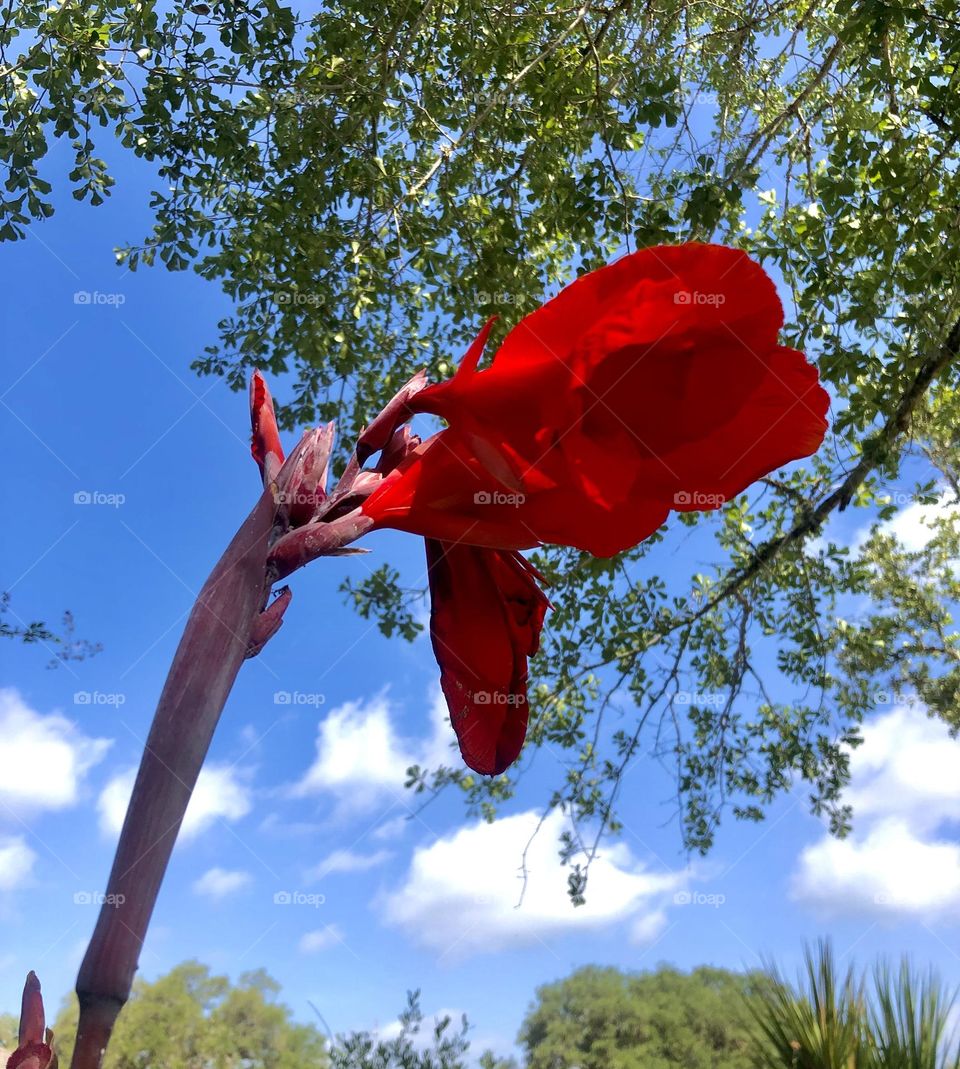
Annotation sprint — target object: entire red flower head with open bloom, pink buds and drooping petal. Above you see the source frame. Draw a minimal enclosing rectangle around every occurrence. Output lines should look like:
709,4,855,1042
252,244,829,774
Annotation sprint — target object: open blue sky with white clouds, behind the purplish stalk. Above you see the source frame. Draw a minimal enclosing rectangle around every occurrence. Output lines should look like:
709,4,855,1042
0,125,960,1053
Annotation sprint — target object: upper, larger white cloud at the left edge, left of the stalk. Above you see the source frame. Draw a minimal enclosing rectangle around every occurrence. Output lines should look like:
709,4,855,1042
0,687,111,809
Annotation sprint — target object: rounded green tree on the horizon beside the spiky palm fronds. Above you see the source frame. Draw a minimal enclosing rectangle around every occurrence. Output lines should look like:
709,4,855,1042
520,966,750,1069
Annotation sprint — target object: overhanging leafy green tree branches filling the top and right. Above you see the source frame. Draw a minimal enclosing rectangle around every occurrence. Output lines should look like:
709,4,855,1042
0,0,960,859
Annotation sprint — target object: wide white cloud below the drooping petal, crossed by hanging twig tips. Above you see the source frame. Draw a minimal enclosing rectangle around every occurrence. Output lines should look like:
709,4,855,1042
381,810,687,958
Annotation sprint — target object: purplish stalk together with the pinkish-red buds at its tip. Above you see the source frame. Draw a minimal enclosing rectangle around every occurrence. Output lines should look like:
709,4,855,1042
71,374,397,1069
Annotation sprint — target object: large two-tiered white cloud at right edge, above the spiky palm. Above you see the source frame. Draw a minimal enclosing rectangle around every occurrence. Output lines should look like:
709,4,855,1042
792,707,960,915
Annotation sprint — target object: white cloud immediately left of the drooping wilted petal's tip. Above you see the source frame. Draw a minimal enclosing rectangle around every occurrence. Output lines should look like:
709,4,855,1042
293,687,454,810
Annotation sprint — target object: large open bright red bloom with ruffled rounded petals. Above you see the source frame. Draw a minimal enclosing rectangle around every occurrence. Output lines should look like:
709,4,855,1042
363,244,829,556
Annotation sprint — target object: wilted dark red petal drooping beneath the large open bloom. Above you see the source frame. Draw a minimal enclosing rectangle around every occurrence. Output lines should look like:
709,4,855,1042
427,539,549,776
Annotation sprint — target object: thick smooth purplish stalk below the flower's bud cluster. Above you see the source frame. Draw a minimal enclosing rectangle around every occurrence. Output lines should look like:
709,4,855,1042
72,491,273,1069
